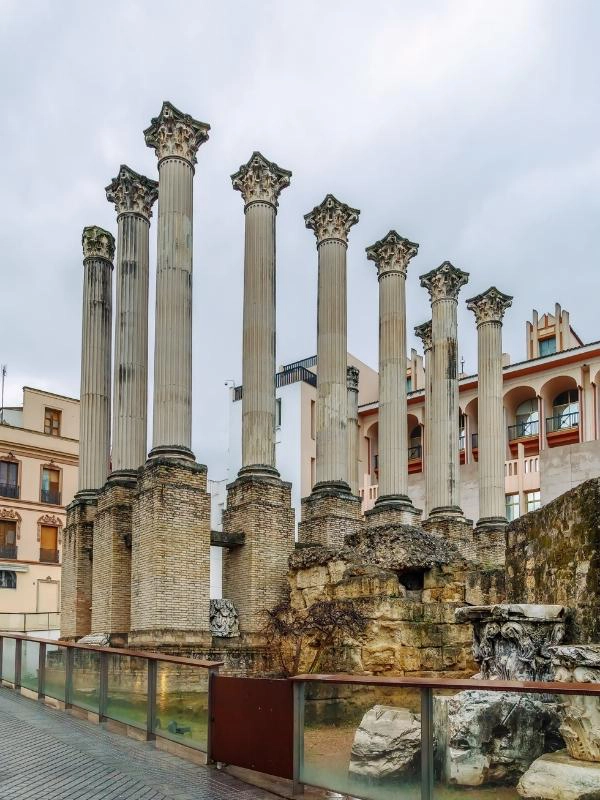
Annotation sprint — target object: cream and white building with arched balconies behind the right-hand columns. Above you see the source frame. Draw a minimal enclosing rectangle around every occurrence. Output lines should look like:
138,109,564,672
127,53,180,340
229,304,600,520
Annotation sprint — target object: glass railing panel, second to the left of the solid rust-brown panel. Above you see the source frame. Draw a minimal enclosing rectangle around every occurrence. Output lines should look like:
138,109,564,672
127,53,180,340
106,655,148,730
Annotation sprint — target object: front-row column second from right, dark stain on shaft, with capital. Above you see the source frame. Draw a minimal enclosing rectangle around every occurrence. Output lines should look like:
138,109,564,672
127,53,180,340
420,261,469,518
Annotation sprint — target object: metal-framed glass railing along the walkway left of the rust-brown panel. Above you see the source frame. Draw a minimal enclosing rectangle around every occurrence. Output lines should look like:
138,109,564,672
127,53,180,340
0,633,223,759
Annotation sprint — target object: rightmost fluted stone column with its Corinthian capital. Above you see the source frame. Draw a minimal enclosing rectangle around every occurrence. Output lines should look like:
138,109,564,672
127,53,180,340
467,286,512,529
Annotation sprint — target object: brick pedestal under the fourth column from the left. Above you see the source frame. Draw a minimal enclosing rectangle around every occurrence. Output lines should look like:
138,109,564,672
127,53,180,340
223,474,295,634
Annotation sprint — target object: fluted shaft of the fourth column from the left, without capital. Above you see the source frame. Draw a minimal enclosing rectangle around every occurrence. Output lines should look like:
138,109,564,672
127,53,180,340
242,202,276,468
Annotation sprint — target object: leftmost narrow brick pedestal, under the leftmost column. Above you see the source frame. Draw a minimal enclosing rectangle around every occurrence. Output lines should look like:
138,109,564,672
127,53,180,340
60,497,97,640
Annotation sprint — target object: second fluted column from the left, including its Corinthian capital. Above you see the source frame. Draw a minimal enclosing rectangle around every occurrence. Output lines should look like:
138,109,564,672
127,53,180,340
106,165,158,477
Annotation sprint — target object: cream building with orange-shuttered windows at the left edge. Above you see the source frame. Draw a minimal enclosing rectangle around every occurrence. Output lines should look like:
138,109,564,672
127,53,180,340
0,387,79,631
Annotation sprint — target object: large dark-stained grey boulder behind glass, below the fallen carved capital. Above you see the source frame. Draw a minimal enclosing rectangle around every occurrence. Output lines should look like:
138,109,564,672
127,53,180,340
433,689,544,800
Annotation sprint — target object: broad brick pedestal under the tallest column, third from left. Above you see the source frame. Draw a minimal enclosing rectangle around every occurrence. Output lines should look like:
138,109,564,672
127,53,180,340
129,458,210,649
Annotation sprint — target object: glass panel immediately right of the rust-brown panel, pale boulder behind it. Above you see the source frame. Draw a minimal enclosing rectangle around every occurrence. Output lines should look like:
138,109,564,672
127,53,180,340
300,681,421,800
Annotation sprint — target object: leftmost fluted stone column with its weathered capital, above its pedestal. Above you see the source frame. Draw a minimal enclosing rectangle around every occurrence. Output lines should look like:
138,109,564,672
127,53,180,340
78,225,115,496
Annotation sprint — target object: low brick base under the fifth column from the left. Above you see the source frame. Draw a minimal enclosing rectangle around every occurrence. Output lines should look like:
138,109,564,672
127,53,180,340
298,489,364,547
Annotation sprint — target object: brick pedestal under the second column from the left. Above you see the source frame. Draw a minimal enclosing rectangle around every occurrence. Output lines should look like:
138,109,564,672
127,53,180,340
92,478,136,646
